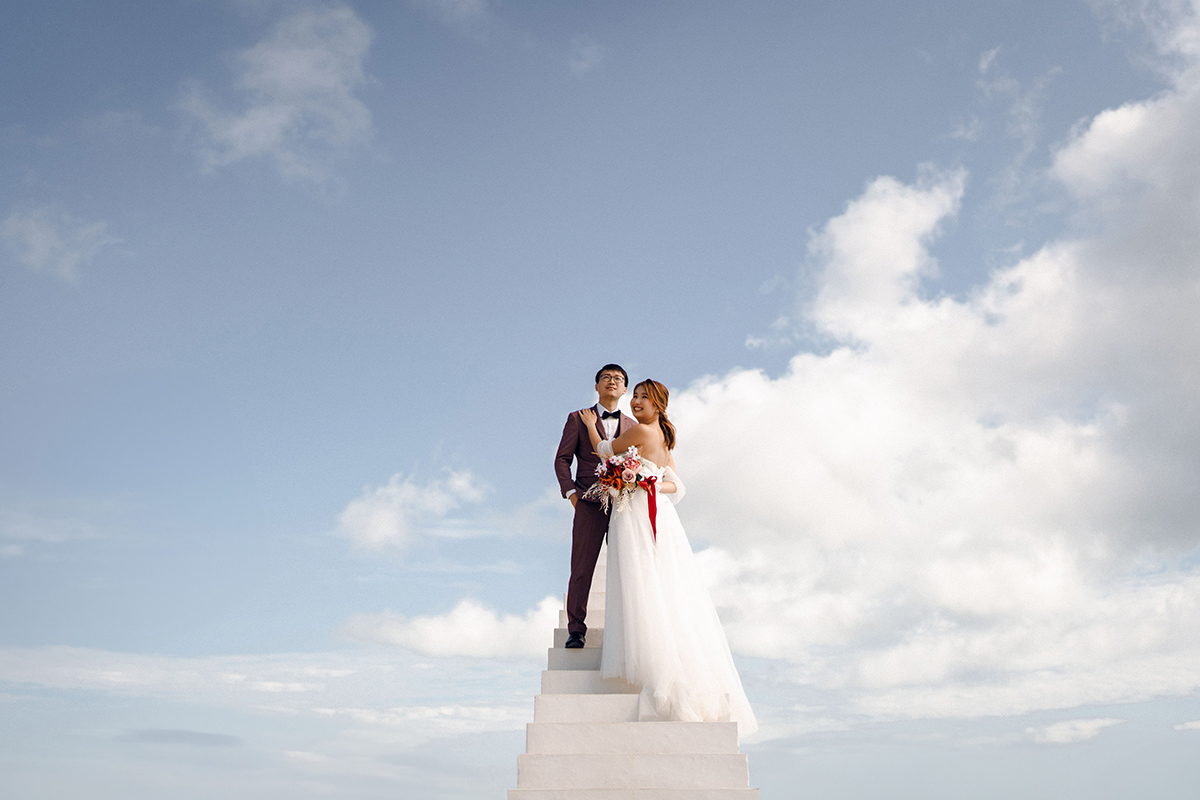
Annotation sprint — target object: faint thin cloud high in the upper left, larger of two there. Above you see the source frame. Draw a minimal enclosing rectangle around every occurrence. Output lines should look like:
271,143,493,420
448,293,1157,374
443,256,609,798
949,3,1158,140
181,7,372,184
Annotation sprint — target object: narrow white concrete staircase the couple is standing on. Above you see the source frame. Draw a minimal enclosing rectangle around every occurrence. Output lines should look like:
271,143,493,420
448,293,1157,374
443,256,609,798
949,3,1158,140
509,549,758,800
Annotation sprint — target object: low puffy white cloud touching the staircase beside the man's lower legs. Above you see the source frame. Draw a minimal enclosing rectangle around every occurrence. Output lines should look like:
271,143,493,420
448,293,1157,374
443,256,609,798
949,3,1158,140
343,597,560,658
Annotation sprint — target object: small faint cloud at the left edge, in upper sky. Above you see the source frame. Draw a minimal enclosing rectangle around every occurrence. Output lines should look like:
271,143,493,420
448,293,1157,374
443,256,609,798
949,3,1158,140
0,207,121,283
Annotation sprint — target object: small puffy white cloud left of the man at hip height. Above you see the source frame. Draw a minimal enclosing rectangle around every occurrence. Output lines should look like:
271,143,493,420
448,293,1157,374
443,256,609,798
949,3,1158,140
337,471,484,549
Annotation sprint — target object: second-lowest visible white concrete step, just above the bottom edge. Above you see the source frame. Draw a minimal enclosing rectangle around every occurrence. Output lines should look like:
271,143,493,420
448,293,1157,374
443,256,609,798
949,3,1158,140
517,753,750,789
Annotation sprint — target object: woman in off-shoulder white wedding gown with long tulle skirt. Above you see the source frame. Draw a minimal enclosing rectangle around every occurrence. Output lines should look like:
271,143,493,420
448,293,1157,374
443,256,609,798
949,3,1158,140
580,380,758,736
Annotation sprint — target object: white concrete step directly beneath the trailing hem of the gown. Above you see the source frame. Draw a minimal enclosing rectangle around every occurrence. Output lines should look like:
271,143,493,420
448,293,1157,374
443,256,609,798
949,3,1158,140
526,722,738,754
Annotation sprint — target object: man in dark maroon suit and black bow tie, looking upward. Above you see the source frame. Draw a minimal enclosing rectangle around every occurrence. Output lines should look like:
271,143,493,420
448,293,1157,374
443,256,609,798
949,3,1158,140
554,363,637,649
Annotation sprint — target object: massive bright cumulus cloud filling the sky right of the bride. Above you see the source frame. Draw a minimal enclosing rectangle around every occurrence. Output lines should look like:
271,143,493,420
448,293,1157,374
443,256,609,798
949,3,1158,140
672,0,1200,724
